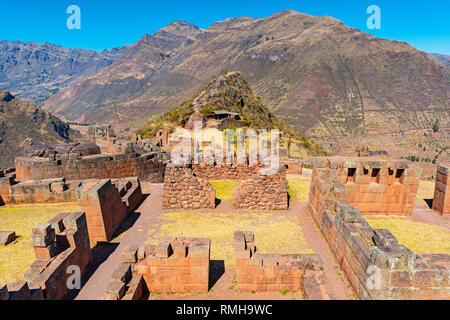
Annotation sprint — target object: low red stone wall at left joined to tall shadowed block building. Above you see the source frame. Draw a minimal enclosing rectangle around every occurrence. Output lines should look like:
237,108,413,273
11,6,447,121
0,166,142,244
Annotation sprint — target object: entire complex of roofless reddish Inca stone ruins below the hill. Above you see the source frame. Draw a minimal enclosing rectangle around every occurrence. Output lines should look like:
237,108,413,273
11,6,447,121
0,127,450,300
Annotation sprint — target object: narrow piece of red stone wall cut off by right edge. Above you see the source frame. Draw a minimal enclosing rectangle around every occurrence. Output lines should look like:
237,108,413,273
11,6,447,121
433,163,450,215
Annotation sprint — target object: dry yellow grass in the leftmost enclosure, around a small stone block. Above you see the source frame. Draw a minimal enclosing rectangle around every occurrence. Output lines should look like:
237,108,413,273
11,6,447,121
0,203,80,284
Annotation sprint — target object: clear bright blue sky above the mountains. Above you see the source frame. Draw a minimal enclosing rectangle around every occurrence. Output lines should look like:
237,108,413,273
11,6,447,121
0,0,450,54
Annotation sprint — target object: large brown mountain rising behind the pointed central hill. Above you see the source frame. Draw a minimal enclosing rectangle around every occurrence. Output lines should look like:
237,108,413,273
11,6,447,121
41,10,450,136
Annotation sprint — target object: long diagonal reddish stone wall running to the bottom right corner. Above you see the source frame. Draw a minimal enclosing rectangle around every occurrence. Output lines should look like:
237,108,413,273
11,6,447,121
307,158,450,300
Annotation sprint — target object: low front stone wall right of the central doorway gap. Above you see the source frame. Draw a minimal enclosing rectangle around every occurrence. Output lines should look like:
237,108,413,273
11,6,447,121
234,231,336,300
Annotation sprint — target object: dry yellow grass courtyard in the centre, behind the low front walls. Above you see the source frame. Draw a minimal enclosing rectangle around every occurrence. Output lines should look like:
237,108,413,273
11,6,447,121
147,212,313,266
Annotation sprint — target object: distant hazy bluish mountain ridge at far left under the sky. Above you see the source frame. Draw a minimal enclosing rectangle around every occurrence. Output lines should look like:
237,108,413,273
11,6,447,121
0,40,128,104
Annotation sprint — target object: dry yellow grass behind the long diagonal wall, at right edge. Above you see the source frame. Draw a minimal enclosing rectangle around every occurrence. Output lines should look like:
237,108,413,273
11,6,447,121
366,216,450,254
